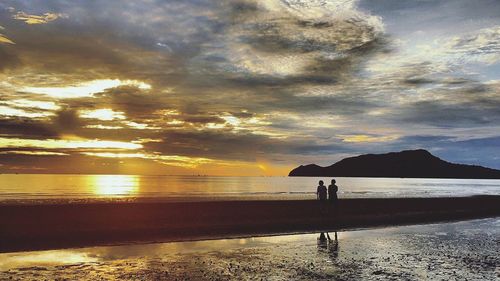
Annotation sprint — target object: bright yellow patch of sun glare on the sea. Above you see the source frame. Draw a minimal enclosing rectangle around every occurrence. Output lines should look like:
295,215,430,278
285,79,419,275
89,175,139,196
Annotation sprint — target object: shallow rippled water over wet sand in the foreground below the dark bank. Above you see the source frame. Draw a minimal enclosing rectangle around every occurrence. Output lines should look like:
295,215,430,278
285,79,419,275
0,218,500,280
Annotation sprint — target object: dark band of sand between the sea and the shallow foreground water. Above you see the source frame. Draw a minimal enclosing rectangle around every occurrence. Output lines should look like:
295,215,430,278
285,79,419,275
0,196,500,252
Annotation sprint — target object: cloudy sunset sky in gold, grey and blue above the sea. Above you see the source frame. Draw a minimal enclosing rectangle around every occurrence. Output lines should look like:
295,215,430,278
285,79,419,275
0,0,500,176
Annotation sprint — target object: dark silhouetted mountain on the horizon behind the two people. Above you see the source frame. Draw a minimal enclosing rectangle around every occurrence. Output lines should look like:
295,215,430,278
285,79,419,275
288,149,500,179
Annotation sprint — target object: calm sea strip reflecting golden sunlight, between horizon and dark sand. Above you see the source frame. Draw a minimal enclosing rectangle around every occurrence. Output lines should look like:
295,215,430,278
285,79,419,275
0,174,500,203
